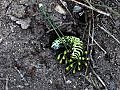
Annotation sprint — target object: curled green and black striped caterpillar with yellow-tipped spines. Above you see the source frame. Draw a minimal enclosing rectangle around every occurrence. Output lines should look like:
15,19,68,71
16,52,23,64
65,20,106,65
51,36,89,73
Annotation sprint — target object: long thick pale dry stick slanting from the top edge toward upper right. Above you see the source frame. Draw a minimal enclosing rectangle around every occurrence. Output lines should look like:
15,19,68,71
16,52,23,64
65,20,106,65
71,0,110,17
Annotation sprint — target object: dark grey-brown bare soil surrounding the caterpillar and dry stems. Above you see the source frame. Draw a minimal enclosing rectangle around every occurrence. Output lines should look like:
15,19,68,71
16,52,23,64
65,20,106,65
0,0,120,90
